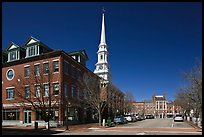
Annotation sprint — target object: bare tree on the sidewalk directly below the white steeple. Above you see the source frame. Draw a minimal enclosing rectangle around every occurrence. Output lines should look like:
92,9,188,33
81,73,111,126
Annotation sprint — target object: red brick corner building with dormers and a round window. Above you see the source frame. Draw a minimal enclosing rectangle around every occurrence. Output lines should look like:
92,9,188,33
2,37,123,125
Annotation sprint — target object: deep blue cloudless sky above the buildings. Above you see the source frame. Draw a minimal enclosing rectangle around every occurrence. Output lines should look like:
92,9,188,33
2,2,202,101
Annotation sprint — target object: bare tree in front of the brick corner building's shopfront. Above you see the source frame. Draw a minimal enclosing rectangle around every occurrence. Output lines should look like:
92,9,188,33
11,61,61,130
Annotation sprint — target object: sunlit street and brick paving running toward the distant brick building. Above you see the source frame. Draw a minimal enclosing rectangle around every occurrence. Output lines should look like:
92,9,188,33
60,118,202,135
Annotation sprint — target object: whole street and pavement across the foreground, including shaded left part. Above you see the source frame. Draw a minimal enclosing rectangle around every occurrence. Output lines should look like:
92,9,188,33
2,118,202,135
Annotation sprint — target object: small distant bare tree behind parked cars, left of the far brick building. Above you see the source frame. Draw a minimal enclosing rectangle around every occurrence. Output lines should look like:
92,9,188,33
124,91,134,114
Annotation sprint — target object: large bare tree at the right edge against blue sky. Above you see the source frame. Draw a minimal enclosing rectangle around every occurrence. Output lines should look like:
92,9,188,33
176,62,202,125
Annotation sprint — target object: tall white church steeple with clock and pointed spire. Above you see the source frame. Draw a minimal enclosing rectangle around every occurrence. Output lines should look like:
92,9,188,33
94,10,111,84
